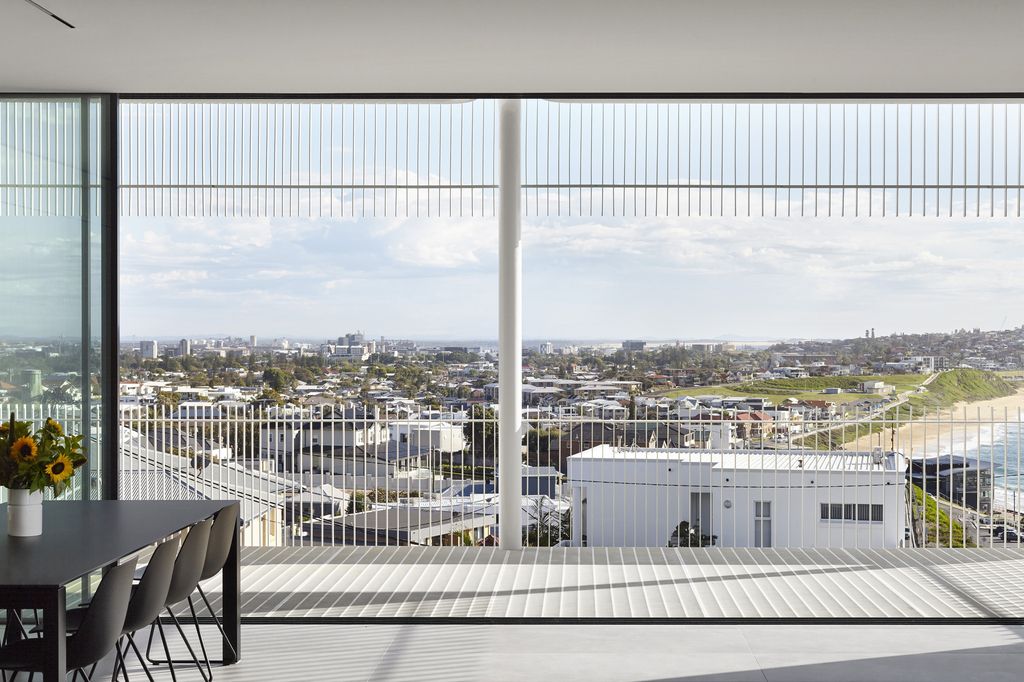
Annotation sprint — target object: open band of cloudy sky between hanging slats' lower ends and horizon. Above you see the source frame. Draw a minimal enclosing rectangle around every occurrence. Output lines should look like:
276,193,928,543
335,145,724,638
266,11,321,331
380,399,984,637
110,210,1024,340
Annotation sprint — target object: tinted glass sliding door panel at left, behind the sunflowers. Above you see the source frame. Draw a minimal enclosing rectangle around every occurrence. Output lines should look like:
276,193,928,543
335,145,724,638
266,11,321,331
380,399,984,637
0,96,116,499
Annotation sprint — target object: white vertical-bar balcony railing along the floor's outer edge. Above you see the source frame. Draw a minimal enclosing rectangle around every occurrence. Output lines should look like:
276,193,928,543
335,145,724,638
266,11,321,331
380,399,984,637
8,403,1024,549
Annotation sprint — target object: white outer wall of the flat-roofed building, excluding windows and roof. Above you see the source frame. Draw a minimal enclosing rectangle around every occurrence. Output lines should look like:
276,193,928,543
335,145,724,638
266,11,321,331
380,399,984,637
568,458,905,549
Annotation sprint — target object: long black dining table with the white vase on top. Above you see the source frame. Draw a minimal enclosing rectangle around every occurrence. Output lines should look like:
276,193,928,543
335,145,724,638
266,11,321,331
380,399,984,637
0,500,242,682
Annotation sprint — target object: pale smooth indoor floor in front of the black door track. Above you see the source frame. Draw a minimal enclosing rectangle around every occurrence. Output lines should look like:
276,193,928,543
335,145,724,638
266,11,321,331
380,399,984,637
23,624,1024,682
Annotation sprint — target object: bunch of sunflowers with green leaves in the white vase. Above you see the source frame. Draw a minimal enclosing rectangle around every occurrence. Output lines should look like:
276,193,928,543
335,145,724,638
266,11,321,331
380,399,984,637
0,415,86,497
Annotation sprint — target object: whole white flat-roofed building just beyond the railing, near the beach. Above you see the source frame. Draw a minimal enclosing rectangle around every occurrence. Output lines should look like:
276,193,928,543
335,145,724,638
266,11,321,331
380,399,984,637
568,444,908,549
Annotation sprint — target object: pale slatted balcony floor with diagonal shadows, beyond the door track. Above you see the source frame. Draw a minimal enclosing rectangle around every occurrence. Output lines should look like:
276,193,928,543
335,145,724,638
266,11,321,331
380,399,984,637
203,547,1024,622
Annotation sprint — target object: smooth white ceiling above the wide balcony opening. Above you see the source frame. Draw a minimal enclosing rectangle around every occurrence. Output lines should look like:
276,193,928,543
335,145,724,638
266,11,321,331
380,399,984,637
0,0,1024,93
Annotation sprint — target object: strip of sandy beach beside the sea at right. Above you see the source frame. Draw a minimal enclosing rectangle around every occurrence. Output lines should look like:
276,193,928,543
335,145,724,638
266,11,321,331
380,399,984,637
846,387,1024,457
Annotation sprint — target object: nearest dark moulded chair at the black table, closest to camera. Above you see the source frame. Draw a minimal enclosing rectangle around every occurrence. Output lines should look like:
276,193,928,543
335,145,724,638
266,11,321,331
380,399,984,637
0,558,136,682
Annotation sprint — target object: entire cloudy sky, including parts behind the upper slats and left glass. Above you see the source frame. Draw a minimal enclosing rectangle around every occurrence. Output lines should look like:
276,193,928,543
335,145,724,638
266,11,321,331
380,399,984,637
8,100,1024,341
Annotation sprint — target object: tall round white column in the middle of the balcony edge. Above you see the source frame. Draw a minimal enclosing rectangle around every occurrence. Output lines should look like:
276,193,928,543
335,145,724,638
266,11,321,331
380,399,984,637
498,99,522,550
